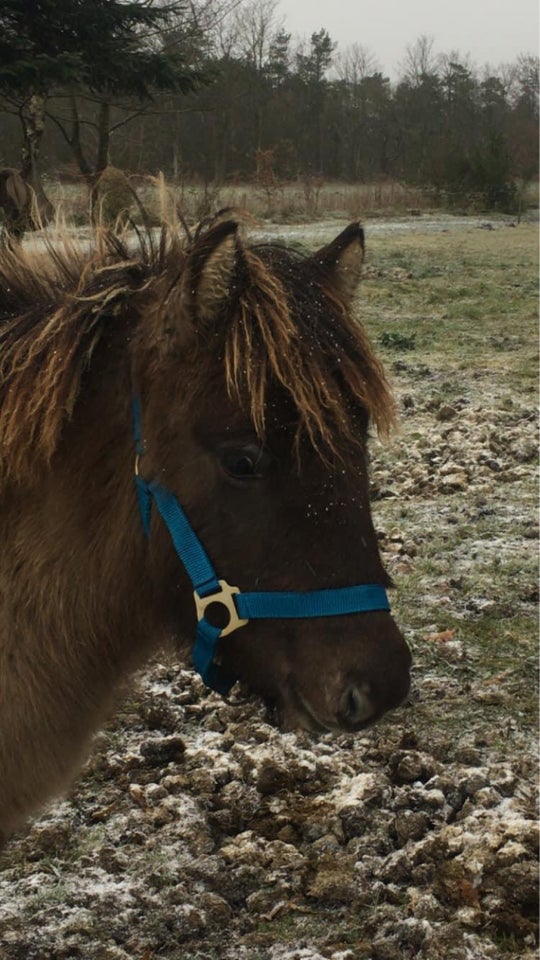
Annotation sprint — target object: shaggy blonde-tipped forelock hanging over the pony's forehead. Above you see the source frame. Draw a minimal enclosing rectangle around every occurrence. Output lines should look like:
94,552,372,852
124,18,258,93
225,245,394,459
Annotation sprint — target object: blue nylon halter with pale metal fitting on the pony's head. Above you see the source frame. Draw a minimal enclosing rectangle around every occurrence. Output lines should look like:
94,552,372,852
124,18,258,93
133,397,390,694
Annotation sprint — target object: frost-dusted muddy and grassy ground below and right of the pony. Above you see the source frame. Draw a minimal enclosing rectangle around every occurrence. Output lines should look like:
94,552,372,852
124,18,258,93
0,221,538,960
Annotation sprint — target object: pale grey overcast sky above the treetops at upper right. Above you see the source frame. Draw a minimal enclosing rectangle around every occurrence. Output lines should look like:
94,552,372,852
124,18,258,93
276,0,538,78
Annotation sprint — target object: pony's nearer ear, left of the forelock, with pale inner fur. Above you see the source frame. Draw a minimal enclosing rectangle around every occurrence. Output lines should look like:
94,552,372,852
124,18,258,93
184,220,240,325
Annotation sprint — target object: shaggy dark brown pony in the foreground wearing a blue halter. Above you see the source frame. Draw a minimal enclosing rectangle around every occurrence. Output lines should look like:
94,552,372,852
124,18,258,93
0,221,410,834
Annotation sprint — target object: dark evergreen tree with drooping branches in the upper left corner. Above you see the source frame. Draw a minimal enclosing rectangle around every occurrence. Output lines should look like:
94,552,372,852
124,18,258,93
0,0,206,204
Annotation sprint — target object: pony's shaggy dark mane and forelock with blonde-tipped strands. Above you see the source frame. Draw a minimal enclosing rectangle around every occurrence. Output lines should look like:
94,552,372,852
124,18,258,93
0,226,394,478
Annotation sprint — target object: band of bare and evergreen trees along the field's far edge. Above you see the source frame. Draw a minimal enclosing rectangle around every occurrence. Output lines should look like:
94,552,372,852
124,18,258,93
0,0,538,210
